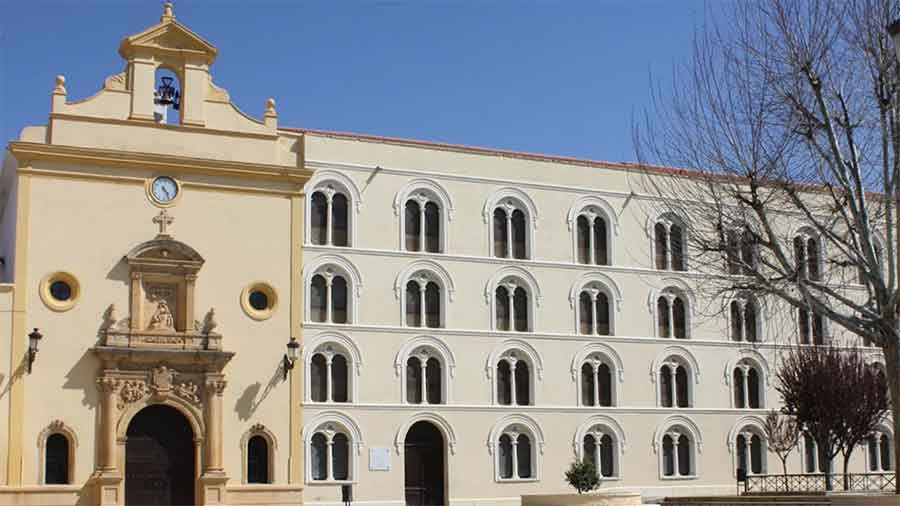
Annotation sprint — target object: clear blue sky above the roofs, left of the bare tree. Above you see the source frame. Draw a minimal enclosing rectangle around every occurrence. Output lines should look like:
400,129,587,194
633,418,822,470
0,0,704,161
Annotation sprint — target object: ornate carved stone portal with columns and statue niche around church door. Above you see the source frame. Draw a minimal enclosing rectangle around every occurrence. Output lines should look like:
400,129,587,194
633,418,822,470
92,211,234,506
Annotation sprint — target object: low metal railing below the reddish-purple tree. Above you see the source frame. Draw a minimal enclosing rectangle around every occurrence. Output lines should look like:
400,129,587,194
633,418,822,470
743,472,895,494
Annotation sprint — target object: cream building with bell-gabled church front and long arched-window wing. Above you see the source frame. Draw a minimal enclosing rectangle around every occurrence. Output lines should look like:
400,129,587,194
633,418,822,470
0,6,891,505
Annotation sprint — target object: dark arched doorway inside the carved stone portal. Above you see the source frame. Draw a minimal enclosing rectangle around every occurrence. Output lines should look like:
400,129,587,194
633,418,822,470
125,404,195,506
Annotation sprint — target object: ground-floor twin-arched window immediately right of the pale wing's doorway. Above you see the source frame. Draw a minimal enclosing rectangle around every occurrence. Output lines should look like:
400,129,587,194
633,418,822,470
491,423,543,481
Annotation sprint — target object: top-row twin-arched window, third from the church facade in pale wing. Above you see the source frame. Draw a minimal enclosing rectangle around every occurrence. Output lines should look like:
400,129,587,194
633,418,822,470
489,196,534,259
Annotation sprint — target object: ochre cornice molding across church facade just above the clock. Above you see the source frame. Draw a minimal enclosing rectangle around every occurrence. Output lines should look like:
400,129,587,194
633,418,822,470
9,141,312,187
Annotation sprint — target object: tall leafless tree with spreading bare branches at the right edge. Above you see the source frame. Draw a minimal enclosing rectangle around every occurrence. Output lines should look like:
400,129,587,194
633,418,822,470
634,0,900,493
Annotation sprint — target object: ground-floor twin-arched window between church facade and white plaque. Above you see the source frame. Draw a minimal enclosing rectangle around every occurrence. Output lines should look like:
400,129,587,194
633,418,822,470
304,418,362,483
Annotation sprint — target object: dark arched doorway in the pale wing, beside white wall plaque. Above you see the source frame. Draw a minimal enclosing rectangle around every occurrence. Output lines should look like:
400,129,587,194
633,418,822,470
403,421,446,506
